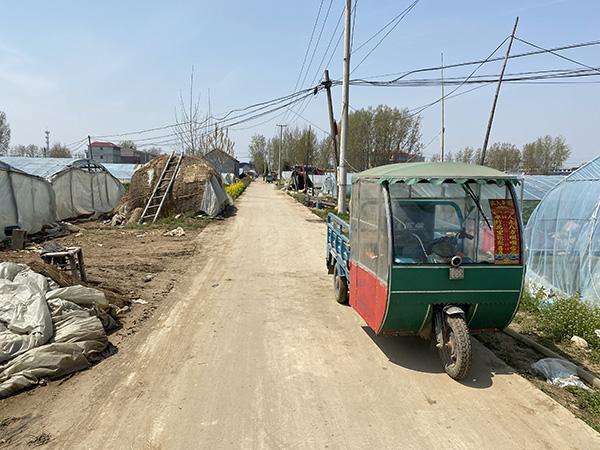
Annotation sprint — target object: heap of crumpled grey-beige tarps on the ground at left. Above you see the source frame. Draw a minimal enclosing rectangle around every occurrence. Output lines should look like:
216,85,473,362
0,262,115,398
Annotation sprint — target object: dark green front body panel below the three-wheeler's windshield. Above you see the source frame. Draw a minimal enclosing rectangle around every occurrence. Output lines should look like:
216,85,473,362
380,265,523,333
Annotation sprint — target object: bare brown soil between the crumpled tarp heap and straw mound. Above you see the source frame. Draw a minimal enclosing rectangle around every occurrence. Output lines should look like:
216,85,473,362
0,222,201,347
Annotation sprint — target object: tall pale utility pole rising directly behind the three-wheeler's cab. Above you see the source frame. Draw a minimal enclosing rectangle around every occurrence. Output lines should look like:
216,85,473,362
337,0,352,213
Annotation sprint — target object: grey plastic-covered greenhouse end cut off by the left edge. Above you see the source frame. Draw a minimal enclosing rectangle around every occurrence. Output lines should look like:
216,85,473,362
0,162,56,239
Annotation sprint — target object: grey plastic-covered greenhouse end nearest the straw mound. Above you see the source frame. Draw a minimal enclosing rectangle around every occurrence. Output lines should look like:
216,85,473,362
50,163,125,220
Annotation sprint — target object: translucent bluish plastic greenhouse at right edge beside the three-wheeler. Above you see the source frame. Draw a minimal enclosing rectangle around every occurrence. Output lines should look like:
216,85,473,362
525,157,600,303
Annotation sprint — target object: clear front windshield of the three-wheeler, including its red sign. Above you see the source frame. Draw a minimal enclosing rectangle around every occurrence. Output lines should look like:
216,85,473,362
389,183,521,264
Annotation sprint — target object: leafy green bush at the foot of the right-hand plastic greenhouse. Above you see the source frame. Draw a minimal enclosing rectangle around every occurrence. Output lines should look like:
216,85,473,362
538,297,600,348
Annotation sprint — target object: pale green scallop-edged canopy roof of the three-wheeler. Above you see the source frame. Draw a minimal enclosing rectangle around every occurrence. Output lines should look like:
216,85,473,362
352,162,518,183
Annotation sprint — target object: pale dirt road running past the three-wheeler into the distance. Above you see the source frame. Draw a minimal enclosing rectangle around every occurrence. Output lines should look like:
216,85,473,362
2,183,600,449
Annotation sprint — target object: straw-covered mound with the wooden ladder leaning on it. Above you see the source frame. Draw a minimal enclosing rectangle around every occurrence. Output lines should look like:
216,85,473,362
112,155,231,226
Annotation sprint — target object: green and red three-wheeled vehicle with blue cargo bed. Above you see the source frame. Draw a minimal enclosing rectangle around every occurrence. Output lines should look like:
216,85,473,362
327,163,524,379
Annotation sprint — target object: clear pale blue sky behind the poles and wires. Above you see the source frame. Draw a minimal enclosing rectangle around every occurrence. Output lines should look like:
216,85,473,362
0,0,600,165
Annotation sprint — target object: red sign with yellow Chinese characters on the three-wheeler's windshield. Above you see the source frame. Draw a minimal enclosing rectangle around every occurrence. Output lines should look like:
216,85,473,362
490,200,521,264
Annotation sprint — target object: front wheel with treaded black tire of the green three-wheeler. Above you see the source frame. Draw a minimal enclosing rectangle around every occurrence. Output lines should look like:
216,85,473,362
439,316,473,380
